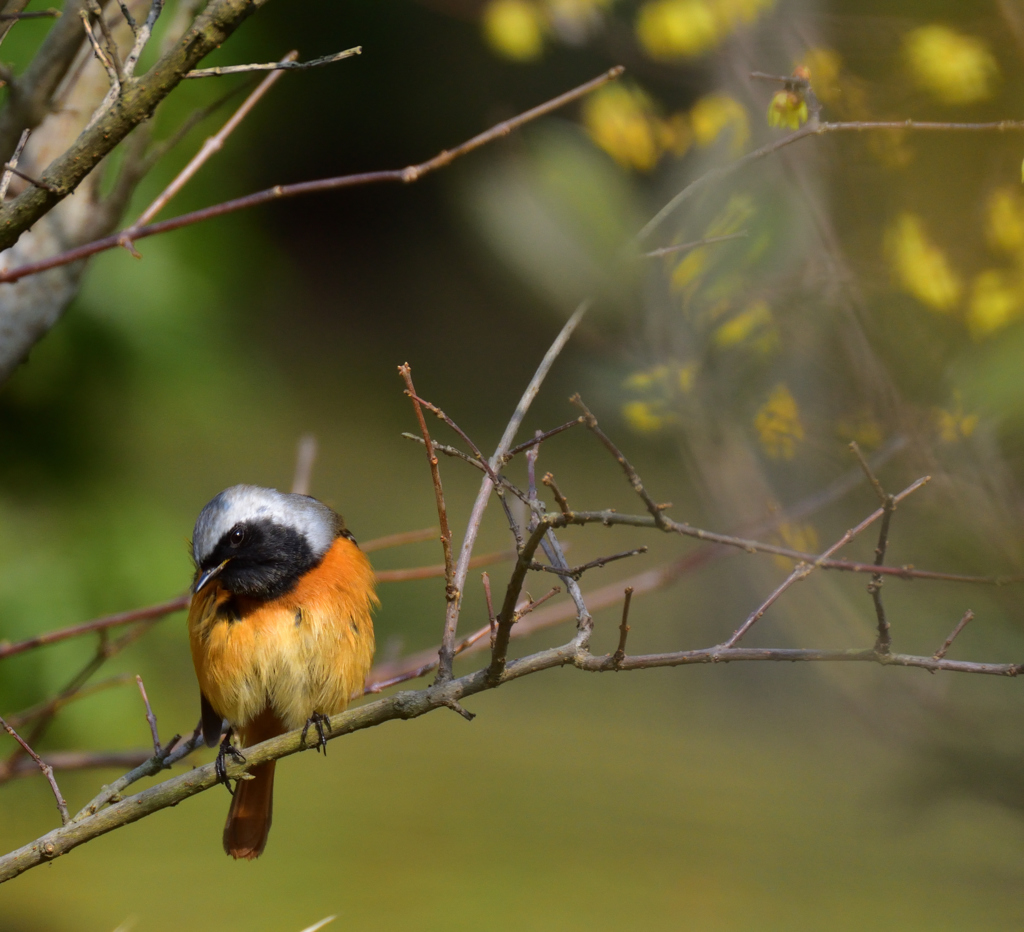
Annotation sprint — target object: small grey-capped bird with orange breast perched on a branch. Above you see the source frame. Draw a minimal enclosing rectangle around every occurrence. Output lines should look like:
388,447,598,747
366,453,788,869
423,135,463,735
187,485,379,860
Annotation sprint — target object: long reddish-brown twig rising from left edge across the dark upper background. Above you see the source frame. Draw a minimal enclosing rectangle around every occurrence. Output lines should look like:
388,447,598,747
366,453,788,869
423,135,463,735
0,70,623,283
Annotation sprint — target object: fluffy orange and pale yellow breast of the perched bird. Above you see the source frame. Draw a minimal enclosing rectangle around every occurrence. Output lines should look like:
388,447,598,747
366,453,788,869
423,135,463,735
188,538,377,731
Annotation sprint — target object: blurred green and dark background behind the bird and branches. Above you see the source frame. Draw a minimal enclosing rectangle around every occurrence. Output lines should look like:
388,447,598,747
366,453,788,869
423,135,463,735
0,0,1024,932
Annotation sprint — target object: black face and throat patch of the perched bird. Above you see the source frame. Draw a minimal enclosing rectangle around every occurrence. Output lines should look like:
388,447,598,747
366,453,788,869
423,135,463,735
194,520,319,599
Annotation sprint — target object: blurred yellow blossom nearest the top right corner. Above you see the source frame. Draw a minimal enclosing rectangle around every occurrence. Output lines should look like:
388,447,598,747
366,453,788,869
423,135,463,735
904,24,999,103
